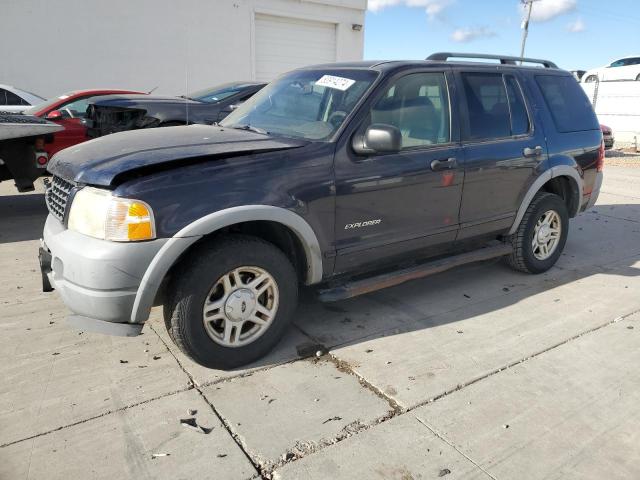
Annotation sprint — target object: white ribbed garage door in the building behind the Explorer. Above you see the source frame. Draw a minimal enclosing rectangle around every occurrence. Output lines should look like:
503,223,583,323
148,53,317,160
254,14,336,81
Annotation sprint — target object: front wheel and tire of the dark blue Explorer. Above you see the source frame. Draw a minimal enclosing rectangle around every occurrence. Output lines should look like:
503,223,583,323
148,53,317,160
164,235,298,369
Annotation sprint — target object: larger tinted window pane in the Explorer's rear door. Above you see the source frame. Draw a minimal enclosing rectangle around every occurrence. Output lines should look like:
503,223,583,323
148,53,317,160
462,73,511,140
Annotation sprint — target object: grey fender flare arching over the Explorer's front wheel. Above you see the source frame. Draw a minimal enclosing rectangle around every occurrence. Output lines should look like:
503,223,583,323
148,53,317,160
131,205,323,323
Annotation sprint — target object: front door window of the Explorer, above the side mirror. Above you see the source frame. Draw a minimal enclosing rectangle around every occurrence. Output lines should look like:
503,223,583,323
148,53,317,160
371,73,451,149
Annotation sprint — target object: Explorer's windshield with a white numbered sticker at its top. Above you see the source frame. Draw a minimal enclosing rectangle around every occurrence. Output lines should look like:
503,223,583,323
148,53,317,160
220,69,377,140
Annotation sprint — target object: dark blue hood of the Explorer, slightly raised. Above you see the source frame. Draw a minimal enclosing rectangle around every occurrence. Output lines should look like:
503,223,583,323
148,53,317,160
47,125,308,187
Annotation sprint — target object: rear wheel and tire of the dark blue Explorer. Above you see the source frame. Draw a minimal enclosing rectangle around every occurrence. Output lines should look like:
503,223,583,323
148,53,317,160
506,192,569,273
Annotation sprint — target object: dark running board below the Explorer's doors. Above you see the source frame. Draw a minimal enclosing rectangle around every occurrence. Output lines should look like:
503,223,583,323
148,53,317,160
318,243,512,302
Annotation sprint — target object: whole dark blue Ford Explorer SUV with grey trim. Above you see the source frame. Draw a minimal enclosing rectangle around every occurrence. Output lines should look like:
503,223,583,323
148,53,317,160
40,53,604,368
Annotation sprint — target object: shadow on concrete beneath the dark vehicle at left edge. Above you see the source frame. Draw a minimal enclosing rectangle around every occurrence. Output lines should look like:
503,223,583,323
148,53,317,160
0,193,48,244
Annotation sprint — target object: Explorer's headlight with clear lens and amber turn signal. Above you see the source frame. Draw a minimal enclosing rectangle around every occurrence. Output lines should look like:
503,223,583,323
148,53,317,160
68,187,156,242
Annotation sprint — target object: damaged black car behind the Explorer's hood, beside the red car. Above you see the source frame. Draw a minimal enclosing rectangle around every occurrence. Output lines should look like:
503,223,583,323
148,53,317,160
86,82,265,137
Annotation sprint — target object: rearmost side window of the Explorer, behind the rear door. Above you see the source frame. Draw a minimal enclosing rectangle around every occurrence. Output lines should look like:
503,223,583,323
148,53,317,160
536,75,600,133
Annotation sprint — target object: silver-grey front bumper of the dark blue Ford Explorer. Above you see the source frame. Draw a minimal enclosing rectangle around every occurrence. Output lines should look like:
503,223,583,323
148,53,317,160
40,215,166,335
